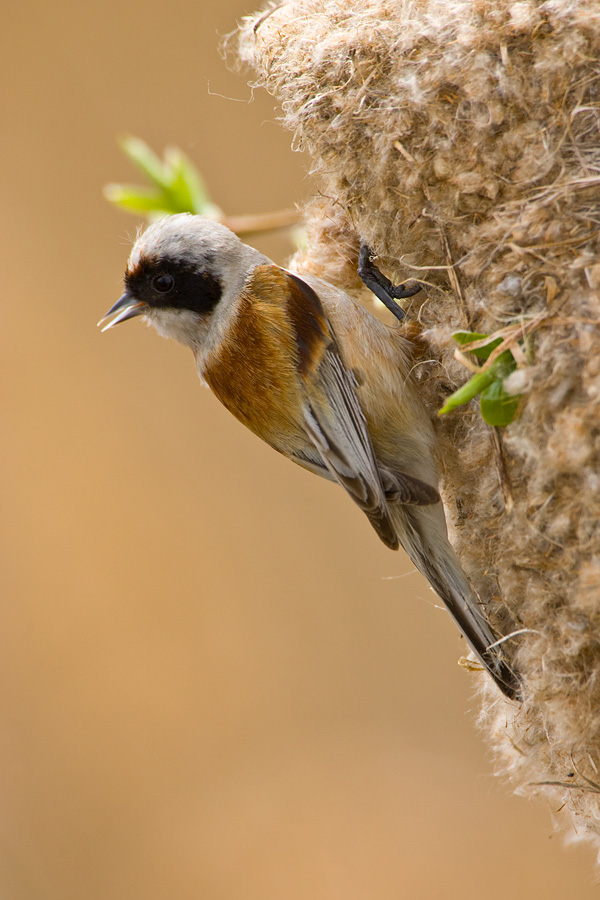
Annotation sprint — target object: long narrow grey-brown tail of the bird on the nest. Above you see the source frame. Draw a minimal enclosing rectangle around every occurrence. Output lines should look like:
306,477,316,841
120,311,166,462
395,506,522,700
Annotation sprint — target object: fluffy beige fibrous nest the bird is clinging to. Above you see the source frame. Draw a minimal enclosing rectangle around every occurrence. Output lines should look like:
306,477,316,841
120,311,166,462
233,0,600,841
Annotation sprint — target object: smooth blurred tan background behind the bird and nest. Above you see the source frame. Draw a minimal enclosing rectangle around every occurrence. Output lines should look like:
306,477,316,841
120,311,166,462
0,0,598,900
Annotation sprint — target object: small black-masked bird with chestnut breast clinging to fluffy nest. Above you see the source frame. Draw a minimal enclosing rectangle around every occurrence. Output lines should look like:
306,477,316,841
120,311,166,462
98,213,522,700
